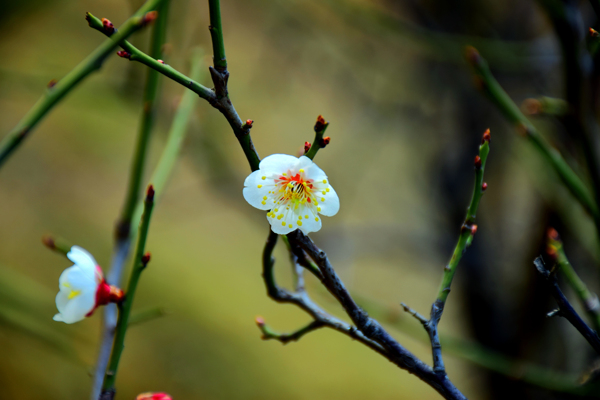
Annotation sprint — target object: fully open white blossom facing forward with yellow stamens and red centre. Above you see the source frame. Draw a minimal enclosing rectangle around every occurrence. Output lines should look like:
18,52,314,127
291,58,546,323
244,154,340,235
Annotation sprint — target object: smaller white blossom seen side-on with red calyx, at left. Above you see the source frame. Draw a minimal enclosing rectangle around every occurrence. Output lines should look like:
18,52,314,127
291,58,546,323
54,246,123,324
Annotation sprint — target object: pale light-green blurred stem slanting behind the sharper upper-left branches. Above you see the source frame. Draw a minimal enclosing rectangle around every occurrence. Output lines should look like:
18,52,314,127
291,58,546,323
131,50,204,237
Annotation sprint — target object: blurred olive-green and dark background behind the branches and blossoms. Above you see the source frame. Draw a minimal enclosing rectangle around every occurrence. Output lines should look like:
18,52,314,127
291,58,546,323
0,0,600,400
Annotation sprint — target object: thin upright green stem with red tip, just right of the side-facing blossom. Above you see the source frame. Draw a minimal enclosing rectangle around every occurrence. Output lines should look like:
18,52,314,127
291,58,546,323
102,185,154,392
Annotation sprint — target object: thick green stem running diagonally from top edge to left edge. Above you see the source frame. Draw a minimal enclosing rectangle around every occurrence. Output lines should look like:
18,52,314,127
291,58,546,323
0,0,164,167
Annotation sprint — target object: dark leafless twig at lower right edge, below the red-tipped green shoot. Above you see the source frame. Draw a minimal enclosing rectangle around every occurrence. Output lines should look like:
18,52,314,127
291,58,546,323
533,257,600,354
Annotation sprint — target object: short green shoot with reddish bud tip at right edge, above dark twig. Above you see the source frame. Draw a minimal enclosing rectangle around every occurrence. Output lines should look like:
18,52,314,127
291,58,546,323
548,234,600,332
